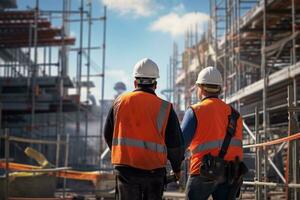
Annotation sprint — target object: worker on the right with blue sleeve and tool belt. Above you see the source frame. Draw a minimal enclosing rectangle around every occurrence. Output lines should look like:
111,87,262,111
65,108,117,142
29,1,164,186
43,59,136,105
182,67,243,200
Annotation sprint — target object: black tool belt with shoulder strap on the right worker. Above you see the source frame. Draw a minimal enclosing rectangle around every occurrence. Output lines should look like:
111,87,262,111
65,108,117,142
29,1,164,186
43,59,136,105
200,107,248,185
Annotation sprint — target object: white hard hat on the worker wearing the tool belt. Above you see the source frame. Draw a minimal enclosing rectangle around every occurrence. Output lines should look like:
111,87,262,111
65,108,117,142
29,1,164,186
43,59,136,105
196,66,223,86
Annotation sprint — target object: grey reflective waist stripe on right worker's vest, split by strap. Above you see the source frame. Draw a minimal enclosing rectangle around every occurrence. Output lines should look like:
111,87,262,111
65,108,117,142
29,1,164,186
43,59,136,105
192,138,243,154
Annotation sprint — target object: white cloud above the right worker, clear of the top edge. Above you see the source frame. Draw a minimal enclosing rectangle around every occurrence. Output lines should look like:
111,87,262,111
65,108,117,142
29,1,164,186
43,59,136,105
150,12,209,37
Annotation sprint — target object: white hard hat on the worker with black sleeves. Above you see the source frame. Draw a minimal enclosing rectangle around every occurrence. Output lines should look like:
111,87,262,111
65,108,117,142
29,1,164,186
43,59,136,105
133,58,159,79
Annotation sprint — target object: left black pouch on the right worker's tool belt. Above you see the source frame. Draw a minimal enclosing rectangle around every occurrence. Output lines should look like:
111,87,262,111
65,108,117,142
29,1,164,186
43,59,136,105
200,154,227,183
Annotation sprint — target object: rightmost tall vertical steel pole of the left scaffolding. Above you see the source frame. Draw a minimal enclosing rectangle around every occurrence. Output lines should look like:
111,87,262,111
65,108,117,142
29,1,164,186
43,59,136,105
99,6,107,168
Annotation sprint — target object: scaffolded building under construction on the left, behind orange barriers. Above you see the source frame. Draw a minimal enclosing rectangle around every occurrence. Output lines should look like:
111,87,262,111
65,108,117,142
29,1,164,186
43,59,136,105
0,0,110,199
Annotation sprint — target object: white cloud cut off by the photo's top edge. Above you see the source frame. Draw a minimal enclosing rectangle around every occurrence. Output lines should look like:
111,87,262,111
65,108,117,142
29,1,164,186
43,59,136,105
102,0,159,17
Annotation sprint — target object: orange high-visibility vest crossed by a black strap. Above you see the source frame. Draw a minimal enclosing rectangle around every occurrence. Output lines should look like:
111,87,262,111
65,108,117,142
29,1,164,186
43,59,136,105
189,98,243,174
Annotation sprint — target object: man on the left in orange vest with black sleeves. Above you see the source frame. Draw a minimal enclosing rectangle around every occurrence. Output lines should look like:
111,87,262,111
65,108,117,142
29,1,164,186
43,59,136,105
104,58,184,200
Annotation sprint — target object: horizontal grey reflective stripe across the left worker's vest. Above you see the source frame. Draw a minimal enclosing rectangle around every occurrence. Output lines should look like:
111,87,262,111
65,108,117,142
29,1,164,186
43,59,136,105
112,138,167,153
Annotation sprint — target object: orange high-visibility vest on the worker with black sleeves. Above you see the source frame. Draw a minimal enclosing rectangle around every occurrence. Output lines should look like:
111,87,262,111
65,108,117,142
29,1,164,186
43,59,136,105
111,91,171,170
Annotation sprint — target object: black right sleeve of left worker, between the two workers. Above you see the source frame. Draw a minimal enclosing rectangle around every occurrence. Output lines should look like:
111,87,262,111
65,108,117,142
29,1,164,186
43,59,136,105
165,107,184,172
